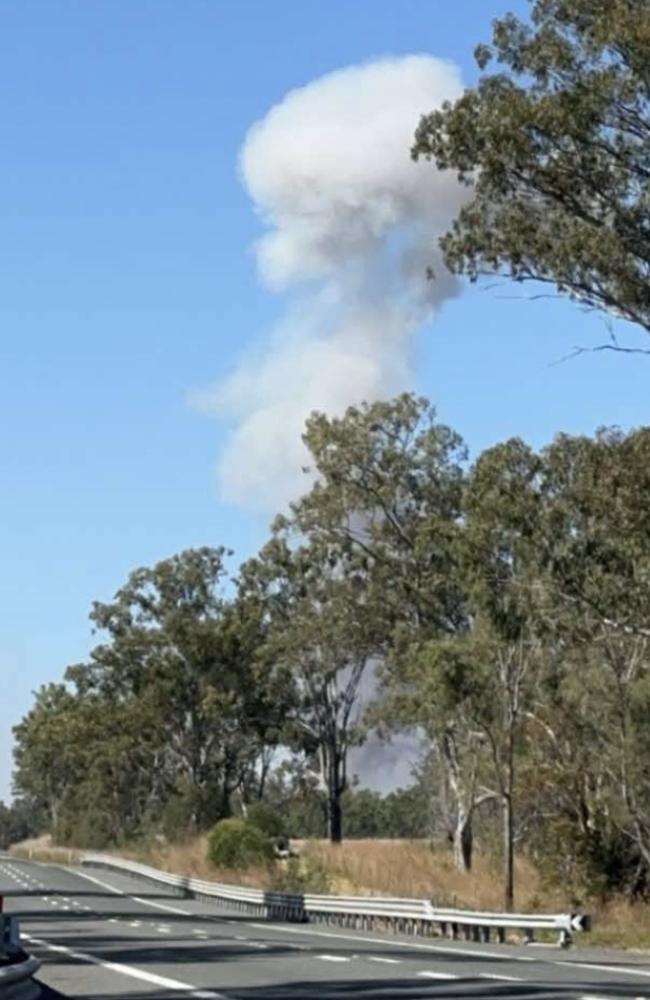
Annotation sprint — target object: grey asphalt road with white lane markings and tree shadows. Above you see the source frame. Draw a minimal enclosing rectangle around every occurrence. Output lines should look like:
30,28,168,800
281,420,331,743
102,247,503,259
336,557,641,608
0,858,650,1000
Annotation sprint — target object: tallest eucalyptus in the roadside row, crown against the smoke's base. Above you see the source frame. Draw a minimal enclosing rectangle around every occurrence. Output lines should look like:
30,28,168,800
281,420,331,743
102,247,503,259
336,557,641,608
280,394,470,848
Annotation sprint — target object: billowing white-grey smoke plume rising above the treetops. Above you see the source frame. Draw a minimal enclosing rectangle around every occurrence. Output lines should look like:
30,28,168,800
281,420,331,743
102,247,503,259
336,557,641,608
193,55,463,510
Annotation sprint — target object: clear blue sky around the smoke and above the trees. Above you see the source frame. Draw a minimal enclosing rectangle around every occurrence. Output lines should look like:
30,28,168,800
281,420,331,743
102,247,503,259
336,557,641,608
0,0,650,797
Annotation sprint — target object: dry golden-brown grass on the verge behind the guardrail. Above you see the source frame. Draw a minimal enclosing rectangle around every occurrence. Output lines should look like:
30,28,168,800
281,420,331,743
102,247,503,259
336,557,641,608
12,837,650,950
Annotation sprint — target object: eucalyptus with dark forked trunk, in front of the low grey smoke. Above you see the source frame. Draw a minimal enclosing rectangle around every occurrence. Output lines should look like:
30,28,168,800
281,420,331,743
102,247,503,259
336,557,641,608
240,521,379,843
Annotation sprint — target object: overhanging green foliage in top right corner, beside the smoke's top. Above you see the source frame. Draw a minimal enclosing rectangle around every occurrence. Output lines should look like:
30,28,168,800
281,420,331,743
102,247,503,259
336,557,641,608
413,0,650,346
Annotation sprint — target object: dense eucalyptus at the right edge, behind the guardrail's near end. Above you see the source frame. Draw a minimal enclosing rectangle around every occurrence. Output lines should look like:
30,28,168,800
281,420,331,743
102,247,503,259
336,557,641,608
543,428,650,887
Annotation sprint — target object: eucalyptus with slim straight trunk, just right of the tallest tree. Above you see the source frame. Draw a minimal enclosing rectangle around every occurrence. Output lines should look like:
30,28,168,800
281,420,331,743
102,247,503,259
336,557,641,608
386,440,543,908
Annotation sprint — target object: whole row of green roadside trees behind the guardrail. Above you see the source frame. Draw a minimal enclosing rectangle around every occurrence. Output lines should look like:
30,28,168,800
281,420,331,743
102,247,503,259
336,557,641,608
15,394,650,906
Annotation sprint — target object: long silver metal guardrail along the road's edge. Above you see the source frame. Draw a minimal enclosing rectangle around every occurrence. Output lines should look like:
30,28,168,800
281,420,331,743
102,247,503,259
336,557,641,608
80,854,591,947
